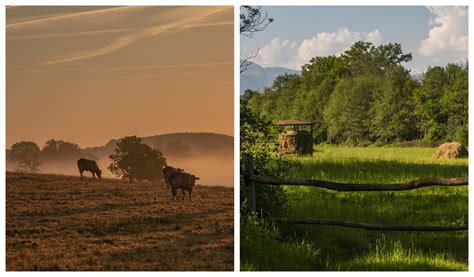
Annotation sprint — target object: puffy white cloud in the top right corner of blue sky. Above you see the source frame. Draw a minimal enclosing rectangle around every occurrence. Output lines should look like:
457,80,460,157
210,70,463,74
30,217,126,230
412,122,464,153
418,6,468,58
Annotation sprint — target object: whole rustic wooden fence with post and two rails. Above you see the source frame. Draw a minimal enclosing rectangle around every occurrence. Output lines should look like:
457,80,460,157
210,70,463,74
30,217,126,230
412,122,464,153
241,154,468,232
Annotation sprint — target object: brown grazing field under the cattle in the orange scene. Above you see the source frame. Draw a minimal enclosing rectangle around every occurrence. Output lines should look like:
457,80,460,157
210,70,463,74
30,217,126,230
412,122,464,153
6,172,234,271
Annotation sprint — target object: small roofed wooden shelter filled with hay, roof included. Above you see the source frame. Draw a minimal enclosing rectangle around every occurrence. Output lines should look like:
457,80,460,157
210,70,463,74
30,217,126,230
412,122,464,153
277,120,316,155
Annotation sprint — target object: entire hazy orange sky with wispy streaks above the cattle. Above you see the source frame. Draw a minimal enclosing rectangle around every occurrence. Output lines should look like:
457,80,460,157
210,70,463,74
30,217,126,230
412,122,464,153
6,6,234,147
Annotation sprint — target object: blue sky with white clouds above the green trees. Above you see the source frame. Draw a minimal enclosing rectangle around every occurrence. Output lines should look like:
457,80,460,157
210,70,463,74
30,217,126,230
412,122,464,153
241,6,468,72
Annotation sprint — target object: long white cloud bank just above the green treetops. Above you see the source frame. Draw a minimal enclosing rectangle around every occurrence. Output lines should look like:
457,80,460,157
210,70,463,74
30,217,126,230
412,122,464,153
254,27,382,70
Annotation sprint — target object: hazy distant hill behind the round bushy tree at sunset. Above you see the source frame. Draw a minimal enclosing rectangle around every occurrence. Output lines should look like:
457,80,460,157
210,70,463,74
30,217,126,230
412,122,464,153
84,133,234,158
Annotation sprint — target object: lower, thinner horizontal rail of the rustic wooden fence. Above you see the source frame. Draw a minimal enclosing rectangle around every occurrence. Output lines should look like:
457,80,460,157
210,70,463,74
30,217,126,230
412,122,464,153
271,218,468,232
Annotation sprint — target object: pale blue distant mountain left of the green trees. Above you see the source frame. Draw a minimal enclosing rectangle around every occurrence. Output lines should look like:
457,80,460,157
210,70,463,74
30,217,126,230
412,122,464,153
240,62,299,95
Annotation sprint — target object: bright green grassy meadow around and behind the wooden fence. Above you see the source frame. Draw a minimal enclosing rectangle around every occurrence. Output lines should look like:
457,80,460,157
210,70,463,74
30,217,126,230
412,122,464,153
241,146,468,271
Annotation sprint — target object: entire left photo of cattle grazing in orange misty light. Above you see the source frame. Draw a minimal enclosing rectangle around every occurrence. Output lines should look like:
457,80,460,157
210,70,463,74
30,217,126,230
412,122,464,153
5,6,235,271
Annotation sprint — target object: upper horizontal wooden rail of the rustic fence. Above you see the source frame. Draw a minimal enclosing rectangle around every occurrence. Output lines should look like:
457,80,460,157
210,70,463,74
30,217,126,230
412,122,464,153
244,175,468,191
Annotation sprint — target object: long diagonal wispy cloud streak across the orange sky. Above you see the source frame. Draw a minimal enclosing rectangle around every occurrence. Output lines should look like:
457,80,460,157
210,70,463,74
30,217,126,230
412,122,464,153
43,7,231,65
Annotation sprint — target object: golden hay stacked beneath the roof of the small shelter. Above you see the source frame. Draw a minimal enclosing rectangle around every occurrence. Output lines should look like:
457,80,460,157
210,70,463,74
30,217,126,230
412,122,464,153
278,131,313,155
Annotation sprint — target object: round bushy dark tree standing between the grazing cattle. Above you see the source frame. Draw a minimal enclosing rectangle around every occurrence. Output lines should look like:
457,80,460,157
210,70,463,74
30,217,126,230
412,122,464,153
108,136,166,182
